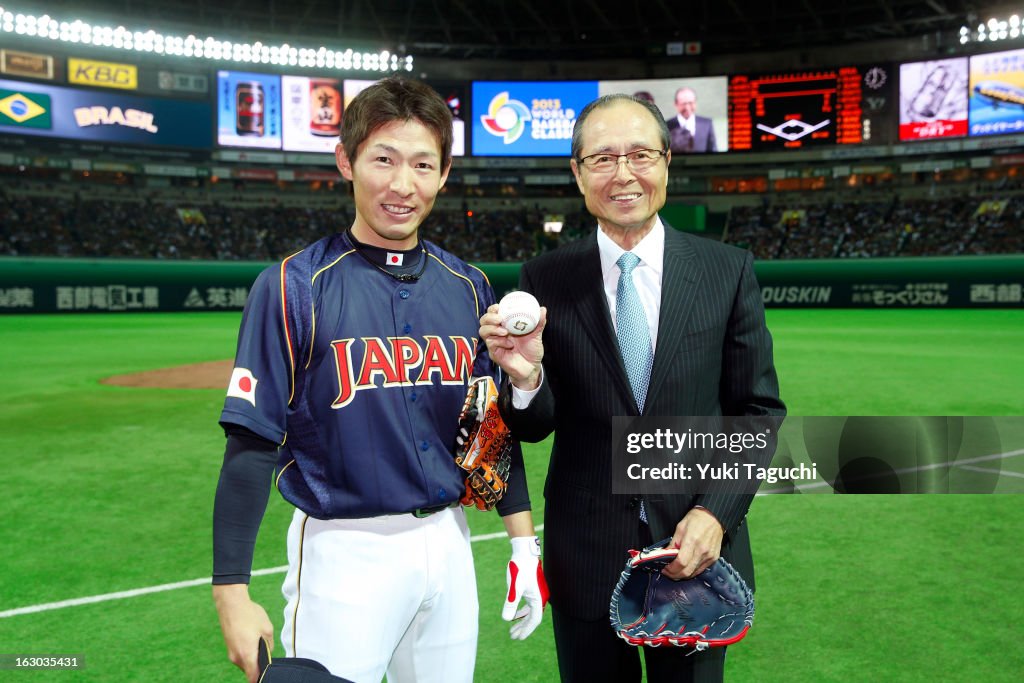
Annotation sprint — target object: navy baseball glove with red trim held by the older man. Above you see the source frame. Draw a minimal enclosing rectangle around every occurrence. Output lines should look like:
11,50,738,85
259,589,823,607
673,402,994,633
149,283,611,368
609,539,754,650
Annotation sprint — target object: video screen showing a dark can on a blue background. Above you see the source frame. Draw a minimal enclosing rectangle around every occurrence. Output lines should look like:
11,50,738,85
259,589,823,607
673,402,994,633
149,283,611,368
217,71,282,150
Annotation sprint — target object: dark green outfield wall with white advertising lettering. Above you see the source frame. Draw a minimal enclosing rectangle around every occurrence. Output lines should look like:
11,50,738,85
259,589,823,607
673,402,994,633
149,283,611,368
0,255,1024,313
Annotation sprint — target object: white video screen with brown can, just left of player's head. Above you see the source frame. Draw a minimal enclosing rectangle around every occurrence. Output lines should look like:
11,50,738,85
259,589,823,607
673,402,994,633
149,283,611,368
281,76,342,154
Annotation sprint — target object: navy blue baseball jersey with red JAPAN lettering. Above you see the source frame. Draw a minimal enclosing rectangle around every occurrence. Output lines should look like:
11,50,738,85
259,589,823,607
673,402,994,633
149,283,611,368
220,233,529,519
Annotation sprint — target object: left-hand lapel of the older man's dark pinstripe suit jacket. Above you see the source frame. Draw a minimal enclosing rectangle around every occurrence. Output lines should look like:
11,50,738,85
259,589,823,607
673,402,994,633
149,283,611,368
567,232,636,410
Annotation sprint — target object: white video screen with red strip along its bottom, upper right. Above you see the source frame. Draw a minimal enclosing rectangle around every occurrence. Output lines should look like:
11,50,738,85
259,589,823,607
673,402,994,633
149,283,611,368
899,57,968,140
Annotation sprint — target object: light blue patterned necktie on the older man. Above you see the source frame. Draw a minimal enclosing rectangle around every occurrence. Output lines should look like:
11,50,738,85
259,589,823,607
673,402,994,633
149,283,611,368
615,252,654,413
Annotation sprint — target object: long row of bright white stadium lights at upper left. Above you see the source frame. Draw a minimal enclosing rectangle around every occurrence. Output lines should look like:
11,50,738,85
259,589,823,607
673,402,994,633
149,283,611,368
0,7,413,72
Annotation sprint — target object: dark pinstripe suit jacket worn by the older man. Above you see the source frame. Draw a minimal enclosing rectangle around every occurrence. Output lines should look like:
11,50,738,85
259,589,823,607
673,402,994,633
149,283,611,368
502,225,785,620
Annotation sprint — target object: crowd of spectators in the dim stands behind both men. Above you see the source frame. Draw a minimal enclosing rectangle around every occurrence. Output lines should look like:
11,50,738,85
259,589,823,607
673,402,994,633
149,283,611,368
0,178,1024,262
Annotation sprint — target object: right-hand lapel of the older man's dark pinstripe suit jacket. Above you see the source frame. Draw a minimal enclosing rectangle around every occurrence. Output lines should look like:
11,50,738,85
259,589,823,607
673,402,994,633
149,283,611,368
647,223,702,405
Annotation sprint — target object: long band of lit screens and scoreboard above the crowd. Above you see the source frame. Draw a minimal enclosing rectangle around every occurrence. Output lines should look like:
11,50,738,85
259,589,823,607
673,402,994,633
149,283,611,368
9,48,1024,157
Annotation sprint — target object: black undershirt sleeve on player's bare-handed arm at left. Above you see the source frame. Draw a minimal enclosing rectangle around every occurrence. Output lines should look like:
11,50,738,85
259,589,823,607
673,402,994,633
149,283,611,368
213,427,278,585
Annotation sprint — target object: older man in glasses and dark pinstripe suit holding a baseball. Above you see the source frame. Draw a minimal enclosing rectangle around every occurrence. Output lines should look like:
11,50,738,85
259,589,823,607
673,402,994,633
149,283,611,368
480,94,785,683
